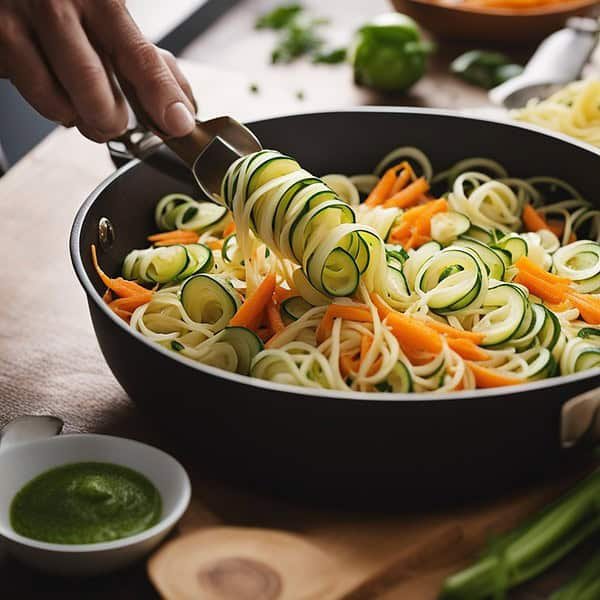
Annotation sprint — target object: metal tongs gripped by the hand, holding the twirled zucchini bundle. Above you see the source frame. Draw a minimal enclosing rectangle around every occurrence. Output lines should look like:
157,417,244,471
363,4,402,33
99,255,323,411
108,86,262,200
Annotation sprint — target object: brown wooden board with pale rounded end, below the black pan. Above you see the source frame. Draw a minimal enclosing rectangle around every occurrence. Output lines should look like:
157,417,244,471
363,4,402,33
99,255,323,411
148,460,588,600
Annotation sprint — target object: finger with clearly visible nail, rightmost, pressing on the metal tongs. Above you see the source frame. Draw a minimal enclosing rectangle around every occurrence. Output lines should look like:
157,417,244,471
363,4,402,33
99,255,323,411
91,2,195,137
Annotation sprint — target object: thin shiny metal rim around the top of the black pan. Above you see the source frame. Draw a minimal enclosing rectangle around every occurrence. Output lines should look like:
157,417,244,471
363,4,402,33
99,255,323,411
69,106,600,403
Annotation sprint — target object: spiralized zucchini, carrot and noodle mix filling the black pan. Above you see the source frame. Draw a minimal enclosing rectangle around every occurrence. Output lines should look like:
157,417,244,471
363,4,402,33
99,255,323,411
107,147,600,393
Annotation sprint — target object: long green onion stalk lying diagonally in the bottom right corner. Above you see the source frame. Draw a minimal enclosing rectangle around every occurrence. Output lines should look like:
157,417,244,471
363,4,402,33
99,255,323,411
440,470,600,600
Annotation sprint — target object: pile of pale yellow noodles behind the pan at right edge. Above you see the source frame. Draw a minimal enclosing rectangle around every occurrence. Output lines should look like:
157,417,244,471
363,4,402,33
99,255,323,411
511,79,600,146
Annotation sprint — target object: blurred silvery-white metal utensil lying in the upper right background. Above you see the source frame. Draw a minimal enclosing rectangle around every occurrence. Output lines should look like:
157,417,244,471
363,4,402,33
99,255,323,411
489,17,600,109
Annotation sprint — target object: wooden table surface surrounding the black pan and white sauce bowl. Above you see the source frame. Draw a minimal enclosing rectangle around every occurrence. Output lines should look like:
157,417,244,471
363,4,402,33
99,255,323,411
0,0,592,600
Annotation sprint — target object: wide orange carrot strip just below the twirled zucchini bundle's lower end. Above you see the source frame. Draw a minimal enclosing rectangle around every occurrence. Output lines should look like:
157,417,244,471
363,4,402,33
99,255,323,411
371,293,443,356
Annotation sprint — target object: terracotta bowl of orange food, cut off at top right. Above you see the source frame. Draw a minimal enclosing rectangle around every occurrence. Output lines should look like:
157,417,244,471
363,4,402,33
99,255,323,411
392,0,600,43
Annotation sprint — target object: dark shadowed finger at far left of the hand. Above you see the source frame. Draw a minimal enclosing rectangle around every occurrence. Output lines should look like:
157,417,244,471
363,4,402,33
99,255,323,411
0,15,76,126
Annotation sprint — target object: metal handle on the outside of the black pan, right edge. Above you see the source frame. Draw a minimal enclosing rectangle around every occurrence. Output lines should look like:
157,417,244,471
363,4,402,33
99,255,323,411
560,387,600,448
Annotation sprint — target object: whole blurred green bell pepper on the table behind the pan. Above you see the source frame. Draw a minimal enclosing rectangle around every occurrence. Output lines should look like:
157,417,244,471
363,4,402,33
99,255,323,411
351,13,433,92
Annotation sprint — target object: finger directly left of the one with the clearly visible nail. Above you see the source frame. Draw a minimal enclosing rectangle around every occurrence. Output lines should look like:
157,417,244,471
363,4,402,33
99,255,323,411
34,0,128,142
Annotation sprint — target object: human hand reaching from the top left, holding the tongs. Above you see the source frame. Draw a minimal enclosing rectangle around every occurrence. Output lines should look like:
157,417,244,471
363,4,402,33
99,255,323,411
0,0,195,142
